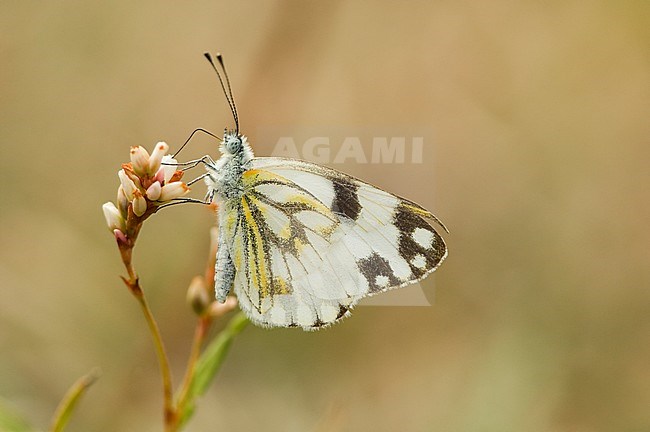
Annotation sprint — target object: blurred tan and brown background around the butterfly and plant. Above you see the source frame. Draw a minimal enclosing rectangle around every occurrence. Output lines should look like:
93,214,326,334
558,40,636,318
0,0,650,432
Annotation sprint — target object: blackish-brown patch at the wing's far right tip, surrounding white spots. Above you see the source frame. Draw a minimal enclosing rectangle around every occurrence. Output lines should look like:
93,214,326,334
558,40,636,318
393,204,447,278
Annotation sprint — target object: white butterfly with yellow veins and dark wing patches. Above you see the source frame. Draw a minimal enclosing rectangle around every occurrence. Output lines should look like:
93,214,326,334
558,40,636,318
190,54,448,330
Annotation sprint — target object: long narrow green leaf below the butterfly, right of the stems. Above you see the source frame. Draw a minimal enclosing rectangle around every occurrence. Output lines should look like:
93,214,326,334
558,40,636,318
180,312,248,423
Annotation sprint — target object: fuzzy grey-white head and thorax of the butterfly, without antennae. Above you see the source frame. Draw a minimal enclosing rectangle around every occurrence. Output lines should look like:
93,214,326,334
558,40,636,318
205,131,253,203
